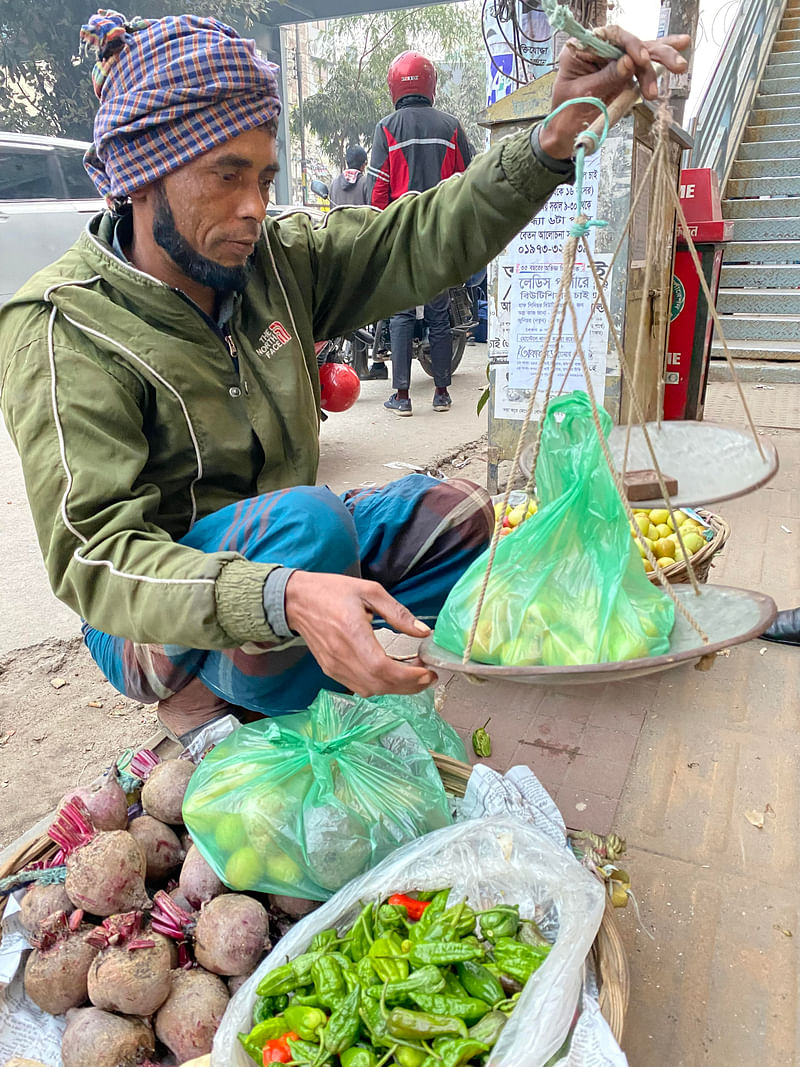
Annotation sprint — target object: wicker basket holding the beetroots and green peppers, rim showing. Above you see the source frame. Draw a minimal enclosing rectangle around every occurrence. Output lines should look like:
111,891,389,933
0,752,630,1042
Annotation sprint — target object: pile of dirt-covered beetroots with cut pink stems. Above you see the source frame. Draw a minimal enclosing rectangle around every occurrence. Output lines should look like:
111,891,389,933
14,750,307,1067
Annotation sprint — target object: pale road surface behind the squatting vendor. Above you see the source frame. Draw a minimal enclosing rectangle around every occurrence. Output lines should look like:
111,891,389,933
0,345,485,655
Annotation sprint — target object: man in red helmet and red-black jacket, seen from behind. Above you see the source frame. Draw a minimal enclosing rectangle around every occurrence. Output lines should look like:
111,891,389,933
367,52,473,415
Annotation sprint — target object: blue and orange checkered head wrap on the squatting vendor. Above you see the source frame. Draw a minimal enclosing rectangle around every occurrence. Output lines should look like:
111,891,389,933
81,11,281,201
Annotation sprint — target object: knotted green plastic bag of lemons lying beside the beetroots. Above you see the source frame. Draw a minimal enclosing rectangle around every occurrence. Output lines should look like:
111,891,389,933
183,690,454,901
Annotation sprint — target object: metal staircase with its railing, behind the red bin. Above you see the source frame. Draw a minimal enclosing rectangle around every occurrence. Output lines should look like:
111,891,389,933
691,0,800,381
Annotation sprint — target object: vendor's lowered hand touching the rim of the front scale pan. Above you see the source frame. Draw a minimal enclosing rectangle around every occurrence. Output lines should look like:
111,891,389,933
285,571,437,697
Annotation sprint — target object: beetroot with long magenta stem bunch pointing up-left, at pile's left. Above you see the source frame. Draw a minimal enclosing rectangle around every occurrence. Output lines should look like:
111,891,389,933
47,799,149,915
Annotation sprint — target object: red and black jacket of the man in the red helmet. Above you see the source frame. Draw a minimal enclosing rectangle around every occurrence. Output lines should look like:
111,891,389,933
369,96,473,208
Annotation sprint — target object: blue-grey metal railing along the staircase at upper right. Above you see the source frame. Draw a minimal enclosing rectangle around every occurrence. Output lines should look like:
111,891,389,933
689,0,786,190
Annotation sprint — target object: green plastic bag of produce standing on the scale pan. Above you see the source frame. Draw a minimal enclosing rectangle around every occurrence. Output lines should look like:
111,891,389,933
435,392,674,667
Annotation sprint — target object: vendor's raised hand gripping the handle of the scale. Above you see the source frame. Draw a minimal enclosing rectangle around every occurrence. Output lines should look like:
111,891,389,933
539,26,689,159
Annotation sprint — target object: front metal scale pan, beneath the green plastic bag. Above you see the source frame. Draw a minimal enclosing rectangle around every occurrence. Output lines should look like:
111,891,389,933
419,585,777,686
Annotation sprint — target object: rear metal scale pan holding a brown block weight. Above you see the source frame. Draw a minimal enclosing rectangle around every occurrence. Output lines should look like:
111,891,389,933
519,421,778,508
